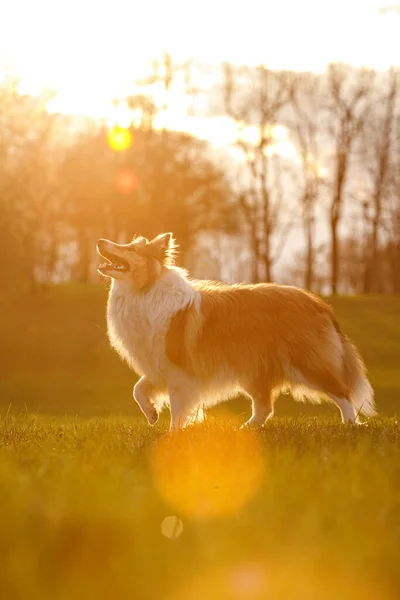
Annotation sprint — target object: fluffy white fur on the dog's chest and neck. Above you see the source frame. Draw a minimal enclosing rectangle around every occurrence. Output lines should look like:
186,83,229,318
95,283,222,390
107,270,198,385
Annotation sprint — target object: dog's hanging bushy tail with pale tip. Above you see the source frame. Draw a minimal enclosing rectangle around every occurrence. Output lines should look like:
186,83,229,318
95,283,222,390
334,323,376,417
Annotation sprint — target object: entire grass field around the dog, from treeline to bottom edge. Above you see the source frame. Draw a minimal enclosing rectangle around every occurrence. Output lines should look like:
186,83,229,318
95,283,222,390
0,286,400,600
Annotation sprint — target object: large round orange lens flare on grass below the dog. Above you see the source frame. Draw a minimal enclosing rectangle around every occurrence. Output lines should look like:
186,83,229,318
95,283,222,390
152,425,264,519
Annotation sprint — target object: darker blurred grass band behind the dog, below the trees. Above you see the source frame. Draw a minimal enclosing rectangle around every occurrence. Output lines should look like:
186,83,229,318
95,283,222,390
0,284,400,420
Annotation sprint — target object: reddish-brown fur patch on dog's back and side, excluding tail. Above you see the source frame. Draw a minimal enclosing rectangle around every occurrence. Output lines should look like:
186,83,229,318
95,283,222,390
167,281,339,379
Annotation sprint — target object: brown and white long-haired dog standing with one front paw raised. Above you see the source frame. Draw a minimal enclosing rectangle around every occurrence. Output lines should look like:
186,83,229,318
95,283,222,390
97,233,375,429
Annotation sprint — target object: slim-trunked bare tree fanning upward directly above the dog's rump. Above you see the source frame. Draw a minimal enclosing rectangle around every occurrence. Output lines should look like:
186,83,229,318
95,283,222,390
326,64,375,294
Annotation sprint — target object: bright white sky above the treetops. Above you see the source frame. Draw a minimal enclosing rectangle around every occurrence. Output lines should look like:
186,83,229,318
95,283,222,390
0,0,400,123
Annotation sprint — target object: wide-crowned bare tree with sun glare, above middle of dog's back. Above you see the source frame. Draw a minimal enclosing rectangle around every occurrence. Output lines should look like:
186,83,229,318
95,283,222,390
223,63,293,281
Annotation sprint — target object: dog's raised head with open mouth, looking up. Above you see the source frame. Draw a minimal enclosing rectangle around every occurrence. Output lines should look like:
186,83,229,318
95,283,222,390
97,233,176,290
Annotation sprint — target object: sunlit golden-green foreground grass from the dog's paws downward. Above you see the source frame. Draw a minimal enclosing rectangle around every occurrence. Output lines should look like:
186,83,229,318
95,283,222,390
0,413,400,600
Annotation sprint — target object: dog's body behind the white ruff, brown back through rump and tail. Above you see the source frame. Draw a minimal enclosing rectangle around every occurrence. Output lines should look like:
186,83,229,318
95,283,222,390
166,282,373,424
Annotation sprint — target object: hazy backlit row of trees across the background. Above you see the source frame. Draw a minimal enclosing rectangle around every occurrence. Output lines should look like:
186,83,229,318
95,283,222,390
0,54,400,293
